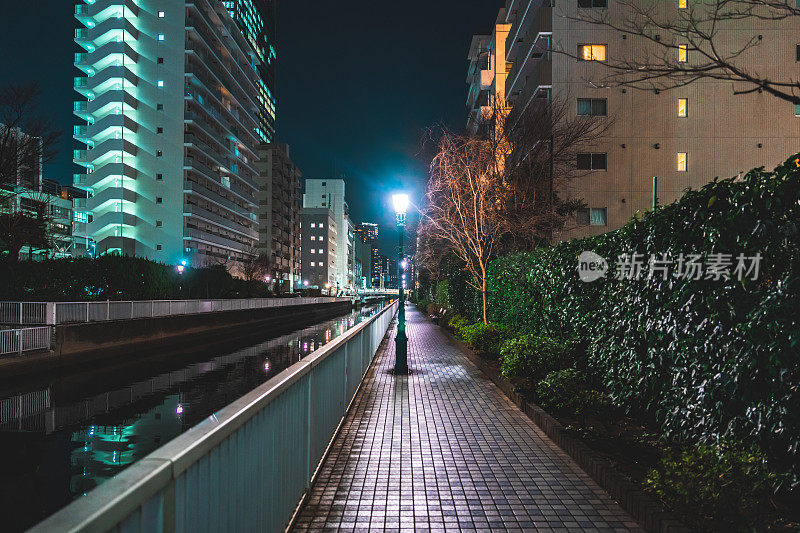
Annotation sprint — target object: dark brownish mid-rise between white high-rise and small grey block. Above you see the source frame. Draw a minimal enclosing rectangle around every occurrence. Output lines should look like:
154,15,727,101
257,144,302,290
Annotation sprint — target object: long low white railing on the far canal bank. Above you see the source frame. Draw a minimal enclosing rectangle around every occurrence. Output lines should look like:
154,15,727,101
0,296,351,326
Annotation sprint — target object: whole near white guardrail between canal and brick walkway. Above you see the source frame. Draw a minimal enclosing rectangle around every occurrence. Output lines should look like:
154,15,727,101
30,301,397,533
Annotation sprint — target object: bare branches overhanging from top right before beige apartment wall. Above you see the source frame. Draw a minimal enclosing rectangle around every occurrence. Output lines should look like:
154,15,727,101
554,0,800,104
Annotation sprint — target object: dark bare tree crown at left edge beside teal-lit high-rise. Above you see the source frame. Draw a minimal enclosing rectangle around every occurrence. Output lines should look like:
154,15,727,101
0,84,60,186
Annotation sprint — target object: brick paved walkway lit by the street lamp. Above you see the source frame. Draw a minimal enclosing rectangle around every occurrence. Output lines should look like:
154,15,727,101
295,306,638,531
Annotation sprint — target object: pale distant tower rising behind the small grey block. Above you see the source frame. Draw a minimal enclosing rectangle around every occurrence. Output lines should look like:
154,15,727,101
303,179,354,289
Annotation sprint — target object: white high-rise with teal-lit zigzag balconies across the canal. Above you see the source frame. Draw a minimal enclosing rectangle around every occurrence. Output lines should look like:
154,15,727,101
74,0,261,265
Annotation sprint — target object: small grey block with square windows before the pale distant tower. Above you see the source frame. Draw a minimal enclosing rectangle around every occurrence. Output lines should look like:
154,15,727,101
300,207,338,290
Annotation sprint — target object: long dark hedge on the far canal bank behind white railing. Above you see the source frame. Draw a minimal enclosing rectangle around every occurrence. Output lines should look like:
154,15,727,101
0,255,269,301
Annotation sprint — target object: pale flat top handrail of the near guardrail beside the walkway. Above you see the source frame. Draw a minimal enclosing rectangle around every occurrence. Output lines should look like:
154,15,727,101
30,301,398,532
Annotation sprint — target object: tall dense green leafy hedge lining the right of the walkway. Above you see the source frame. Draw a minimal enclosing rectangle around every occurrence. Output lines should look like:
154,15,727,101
489,156,800,483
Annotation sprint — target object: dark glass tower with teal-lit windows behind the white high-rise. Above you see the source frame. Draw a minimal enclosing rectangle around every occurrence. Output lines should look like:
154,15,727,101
222,0,276,143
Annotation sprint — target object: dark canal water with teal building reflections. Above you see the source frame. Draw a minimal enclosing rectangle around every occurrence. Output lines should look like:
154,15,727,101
0,306,388,531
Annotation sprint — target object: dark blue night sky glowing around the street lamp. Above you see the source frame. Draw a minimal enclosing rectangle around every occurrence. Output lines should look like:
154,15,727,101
0,0,505,253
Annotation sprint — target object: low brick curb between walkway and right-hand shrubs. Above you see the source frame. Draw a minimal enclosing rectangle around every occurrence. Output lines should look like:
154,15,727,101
434,313,692,533
